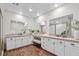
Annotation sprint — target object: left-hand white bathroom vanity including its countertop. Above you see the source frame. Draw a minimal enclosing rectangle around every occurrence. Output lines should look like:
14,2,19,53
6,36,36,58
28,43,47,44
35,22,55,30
5,34,33,50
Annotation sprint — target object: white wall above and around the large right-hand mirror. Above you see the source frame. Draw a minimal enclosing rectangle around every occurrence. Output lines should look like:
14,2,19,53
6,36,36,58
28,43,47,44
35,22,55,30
37,3,79,35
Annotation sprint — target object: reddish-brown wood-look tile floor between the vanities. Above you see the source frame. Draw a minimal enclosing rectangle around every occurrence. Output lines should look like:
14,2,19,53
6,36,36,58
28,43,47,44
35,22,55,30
4,45,54,56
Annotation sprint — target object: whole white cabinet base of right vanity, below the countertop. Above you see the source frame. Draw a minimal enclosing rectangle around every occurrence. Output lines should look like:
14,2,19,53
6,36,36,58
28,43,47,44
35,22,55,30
41,37,79,56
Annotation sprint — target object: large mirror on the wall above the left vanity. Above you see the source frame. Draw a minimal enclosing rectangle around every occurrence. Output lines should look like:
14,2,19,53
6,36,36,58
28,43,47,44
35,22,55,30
10,20,27,34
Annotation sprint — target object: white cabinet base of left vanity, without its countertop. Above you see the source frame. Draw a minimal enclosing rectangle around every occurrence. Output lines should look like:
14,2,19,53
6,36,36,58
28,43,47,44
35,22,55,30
6,36,33,50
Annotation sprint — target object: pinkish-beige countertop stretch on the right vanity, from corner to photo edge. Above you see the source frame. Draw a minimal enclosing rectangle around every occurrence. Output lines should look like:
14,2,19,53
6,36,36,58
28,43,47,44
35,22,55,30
33,34,79,43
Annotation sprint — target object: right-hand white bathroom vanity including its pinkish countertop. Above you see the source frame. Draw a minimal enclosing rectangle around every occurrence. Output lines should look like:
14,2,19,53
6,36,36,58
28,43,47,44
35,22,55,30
32,34,79,56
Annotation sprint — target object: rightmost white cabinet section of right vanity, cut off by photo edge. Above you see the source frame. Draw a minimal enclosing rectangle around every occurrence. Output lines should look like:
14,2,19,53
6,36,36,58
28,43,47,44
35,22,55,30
65,41,79,56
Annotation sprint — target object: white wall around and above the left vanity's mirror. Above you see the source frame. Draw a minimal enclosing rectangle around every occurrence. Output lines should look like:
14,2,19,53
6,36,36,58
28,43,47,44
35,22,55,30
2,8,37,35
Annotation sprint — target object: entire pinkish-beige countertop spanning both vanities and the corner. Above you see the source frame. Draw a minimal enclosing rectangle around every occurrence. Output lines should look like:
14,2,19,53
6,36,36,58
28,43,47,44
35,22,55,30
5,34,79,43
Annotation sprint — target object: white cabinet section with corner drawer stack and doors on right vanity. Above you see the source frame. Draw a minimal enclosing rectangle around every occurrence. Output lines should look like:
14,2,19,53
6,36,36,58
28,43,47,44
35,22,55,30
41,38,64,55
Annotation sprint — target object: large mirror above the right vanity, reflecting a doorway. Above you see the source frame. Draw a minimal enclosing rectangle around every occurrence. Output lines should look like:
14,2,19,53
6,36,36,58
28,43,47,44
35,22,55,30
49,14,73,37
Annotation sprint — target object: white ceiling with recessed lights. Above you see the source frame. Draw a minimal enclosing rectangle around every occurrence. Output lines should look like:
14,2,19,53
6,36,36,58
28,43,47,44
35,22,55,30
0,3,64,18
